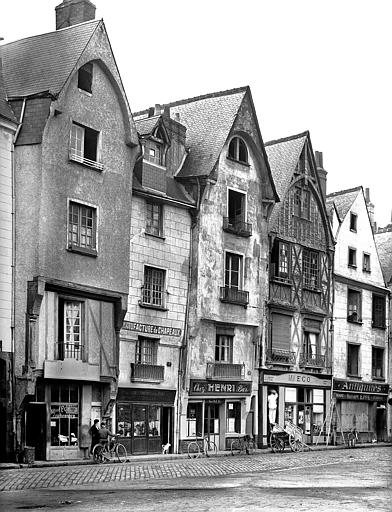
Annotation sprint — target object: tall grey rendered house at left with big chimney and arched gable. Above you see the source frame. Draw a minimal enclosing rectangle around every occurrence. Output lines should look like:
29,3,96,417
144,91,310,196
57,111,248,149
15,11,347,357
1,0,139,459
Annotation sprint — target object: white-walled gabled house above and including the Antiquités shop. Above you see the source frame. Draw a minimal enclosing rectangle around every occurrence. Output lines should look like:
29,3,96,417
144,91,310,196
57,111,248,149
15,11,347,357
327,187,389,442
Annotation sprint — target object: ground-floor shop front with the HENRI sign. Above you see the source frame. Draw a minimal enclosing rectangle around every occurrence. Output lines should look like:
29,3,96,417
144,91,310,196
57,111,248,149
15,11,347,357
180,380,255,452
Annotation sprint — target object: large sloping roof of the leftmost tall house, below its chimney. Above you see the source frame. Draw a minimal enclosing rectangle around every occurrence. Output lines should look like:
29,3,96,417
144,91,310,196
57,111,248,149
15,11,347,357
1,21,102,99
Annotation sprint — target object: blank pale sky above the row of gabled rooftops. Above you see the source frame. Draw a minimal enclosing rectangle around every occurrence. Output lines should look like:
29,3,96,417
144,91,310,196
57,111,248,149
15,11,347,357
0,0,392,227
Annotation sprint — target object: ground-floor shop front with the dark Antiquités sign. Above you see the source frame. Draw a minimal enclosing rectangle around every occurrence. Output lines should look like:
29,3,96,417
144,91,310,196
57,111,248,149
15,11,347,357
333,379,389,443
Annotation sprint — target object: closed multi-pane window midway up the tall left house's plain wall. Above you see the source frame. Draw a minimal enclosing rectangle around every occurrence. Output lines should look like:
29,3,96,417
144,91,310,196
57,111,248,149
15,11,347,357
68,201,97,255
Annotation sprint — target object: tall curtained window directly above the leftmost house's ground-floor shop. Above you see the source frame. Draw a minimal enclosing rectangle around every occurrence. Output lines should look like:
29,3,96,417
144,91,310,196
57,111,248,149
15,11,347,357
57,298,84,360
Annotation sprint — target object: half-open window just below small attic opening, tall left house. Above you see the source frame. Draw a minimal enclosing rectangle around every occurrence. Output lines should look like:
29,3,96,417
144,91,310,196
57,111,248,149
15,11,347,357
69,123,103,170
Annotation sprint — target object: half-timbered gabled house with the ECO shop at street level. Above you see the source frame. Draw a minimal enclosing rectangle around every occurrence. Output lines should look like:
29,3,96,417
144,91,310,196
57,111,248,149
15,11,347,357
259,132,334,443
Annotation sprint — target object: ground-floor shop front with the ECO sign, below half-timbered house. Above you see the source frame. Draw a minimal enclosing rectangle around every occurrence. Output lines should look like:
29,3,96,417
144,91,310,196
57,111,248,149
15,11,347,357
259,370,332,445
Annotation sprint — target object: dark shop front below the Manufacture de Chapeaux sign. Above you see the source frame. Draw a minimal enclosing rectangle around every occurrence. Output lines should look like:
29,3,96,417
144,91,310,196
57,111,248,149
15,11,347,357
116,388,176,454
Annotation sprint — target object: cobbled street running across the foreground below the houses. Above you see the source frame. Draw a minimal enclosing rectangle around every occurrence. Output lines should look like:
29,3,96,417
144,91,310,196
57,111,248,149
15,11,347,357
0,447,392,512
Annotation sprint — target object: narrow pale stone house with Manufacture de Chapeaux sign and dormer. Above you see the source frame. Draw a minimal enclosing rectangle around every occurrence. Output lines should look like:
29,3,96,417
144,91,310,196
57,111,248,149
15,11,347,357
116,105,195,453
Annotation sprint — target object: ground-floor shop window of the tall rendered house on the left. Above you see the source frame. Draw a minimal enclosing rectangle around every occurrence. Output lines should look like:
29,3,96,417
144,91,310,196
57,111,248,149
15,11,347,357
50,383,79,447
